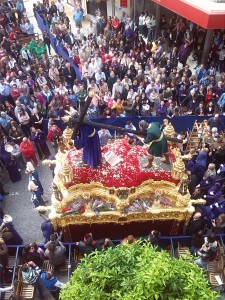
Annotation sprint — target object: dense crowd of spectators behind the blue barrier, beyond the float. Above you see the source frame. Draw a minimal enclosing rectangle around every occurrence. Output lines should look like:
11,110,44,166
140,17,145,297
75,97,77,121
0,0,225,149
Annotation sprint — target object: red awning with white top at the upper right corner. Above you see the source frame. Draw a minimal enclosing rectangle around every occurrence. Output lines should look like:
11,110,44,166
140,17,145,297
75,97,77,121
152,0,225,29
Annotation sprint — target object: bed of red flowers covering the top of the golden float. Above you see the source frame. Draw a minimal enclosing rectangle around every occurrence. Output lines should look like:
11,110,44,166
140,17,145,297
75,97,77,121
67,139,177,188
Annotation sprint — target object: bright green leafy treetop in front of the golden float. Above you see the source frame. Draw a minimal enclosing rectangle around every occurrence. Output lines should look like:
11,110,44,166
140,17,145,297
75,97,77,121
60,242,218,300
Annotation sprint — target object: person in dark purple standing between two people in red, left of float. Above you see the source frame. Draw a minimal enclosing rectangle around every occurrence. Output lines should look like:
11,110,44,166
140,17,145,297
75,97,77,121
30,127,51,159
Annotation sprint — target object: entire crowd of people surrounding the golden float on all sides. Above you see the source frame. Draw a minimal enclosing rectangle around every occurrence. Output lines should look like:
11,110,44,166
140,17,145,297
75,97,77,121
0,0,225,299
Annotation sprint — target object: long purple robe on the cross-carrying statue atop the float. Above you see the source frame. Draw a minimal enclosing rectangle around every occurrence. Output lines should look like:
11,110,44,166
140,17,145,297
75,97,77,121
74,125,102,169
